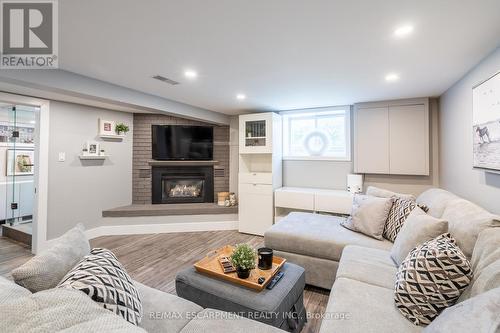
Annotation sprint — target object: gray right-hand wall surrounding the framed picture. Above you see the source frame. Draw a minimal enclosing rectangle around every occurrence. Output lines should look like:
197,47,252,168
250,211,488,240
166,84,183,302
440,48,500,214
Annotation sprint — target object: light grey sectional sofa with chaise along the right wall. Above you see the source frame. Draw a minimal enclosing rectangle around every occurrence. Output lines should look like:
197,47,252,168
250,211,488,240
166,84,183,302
265,189,500,333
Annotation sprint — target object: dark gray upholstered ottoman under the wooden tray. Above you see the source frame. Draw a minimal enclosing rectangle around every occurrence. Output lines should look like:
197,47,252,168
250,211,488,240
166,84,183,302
175,263,307,332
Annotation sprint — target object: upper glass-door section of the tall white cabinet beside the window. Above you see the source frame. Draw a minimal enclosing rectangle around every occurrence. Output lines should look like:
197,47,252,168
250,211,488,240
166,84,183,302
239,112,281,154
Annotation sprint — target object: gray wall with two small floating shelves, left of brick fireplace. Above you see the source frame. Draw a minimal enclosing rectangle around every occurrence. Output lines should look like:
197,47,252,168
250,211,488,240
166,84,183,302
47,101,133,239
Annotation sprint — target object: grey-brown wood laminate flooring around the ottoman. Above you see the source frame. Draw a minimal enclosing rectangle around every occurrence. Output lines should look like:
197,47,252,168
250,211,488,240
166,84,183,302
0,231,329,333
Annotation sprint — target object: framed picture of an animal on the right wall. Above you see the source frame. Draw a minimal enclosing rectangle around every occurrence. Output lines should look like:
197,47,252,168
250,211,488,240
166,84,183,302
472,72,500,172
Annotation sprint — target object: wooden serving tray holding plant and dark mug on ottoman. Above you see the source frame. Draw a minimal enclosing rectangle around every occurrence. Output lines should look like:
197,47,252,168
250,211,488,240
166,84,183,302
194,245,286,291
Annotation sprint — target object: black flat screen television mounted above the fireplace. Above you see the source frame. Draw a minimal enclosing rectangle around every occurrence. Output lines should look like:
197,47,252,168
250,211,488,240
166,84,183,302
151,125,214,161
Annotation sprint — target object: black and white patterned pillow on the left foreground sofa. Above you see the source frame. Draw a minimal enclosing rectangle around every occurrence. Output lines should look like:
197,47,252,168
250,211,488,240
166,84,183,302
58,248,142,325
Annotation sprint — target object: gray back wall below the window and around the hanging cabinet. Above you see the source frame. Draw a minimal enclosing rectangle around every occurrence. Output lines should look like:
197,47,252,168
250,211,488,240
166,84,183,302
283,99,439,195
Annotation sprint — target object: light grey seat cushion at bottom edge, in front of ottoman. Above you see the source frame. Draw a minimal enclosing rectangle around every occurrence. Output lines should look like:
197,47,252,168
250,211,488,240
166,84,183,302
180,309,284,333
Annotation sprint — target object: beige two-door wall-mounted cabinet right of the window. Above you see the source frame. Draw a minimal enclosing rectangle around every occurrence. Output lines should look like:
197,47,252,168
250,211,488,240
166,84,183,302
354,98,430,175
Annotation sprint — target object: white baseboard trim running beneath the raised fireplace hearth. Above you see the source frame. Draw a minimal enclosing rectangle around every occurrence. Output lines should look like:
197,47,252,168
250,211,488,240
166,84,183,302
85,221,238,239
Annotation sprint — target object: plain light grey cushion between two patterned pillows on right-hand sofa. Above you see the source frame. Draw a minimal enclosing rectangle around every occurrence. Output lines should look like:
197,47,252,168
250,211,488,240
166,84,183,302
391,207,448,266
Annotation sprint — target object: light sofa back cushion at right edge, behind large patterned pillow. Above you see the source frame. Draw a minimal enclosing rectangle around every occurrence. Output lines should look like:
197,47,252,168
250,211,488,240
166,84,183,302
460,228,500,301
